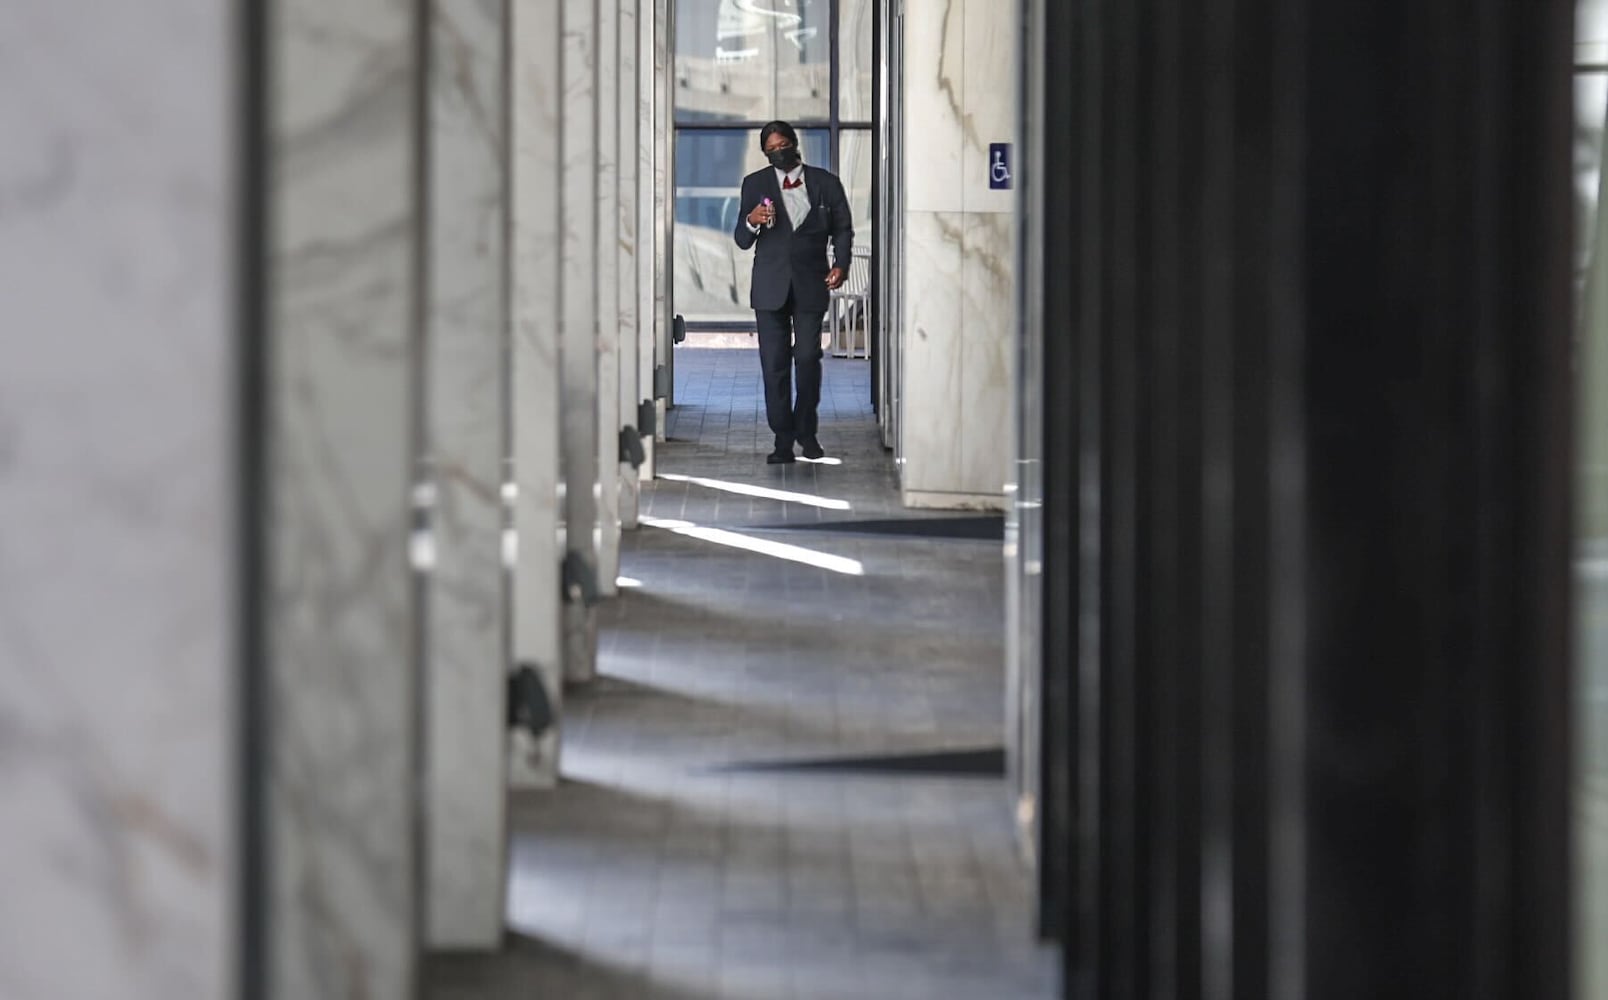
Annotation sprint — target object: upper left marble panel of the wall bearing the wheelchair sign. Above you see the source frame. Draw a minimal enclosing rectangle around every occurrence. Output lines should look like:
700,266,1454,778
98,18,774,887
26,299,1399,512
904,0,958,212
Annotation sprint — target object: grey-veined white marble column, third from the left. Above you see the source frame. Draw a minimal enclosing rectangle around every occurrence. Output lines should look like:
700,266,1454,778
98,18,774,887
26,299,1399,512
423,0,508,949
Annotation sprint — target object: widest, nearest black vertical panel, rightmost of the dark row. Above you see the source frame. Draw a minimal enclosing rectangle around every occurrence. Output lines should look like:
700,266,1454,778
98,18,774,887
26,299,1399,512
1304,0,1571,998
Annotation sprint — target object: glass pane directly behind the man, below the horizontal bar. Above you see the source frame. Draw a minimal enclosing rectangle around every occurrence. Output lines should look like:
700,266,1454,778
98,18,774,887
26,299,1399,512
674,129,829,323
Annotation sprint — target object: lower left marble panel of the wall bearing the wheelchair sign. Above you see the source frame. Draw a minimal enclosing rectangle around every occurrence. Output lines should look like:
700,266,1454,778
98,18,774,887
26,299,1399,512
902,212,965,492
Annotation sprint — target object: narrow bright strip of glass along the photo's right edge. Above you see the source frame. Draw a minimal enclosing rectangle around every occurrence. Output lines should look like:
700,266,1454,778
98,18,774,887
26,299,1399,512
1574,19,1608,1000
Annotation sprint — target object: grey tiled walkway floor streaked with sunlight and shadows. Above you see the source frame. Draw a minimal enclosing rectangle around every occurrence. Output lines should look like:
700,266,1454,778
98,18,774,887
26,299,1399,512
428,350,1055,1000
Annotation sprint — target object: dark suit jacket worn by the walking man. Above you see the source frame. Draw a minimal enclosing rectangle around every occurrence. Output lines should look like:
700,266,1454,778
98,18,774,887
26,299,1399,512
732,164,854,312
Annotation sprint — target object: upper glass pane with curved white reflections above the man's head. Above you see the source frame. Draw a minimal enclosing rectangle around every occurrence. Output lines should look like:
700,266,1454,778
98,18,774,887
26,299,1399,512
675,0,831,122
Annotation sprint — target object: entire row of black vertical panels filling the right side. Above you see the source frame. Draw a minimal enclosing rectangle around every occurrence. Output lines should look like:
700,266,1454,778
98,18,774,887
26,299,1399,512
1023,0,1573,1000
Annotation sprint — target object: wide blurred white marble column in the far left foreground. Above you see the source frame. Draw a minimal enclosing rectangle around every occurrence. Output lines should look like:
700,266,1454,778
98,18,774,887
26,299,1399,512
0,0,244,1000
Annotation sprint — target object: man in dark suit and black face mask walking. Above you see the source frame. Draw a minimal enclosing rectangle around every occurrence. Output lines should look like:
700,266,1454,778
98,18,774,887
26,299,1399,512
732,122,854,465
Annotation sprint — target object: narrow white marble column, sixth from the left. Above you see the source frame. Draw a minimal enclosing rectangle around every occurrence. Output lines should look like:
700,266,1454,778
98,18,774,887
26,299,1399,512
595,0,621,596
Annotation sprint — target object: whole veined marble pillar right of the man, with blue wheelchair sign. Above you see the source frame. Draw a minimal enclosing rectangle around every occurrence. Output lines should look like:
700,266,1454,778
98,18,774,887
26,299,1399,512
900,0,1016,508
